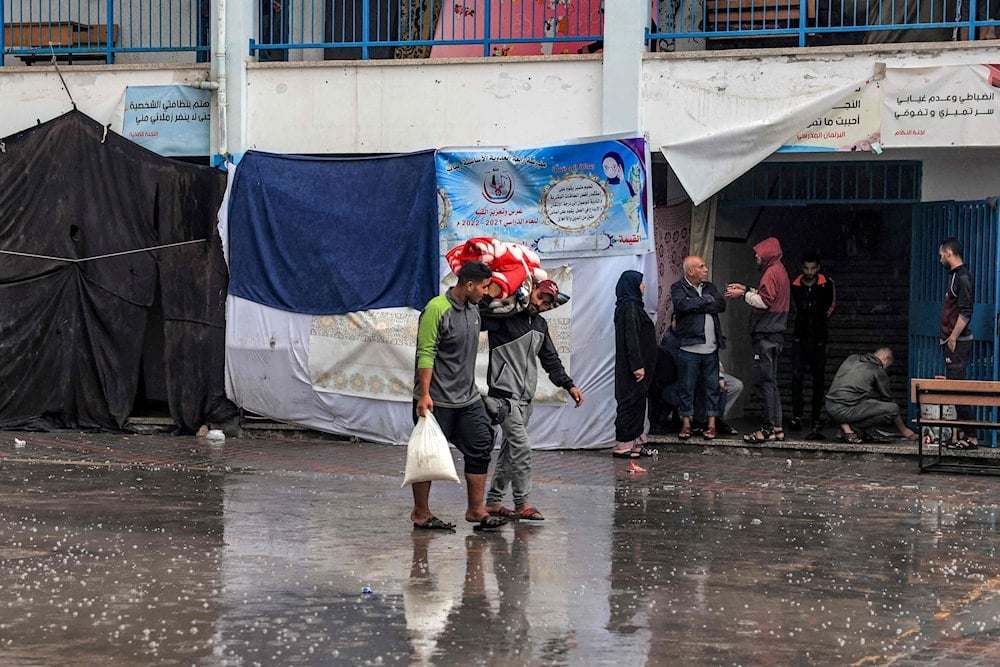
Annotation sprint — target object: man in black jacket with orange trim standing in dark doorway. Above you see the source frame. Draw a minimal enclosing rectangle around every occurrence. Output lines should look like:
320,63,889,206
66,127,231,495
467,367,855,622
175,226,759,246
789,253,837,440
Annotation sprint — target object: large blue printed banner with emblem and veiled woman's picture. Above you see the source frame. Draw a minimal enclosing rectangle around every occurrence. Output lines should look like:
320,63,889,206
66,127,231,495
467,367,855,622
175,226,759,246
436,137,652,260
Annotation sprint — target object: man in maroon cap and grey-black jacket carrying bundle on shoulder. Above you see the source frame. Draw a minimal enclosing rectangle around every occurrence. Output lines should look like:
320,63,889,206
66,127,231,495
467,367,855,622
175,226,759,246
481,280,583,521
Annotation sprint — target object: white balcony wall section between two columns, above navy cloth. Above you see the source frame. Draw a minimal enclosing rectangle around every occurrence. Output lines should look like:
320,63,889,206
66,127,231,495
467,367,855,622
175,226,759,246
247,56,601,153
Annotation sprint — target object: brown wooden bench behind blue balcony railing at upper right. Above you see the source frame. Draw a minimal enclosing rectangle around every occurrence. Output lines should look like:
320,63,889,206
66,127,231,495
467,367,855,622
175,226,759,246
704,0,816,42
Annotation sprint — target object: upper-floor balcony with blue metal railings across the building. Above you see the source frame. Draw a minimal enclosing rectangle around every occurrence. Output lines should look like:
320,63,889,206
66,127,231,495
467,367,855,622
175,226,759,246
0,0,1000,64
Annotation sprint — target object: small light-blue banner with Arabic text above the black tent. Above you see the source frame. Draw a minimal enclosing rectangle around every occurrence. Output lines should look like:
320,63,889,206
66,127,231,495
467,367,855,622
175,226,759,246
122,86,212,156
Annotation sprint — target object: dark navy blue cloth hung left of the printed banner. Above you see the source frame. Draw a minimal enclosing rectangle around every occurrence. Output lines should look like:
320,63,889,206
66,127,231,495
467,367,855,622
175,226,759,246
227,151,438,315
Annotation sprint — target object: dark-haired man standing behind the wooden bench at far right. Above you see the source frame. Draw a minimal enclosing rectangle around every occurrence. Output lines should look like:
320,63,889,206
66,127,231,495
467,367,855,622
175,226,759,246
938,238,979,449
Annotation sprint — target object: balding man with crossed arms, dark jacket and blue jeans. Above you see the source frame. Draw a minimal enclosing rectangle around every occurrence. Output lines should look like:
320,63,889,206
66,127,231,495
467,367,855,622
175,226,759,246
670,255,726,440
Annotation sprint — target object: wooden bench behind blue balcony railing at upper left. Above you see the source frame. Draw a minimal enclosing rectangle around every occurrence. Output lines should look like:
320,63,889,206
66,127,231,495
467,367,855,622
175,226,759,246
3,21,118,65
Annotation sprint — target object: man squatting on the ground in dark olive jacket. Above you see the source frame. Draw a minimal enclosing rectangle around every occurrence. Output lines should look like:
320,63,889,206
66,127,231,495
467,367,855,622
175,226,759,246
826,347,917,445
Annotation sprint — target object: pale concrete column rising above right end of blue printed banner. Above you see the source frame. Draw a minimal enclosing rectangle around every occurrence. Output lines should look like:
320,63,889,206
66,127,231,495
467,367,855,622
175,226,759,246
601,0,650,134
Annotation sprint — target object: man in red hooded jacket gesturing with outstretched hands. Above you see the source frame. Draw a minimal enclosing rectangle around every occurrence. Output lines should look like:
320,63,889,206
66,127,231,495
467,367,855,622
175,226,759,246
725,236,790,443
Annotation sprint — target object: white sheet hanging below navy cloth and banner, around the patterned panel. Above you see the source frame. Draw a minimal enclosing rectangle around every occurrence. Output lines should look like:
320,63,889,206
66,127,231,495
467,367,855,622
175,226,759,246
220,253,657,449
